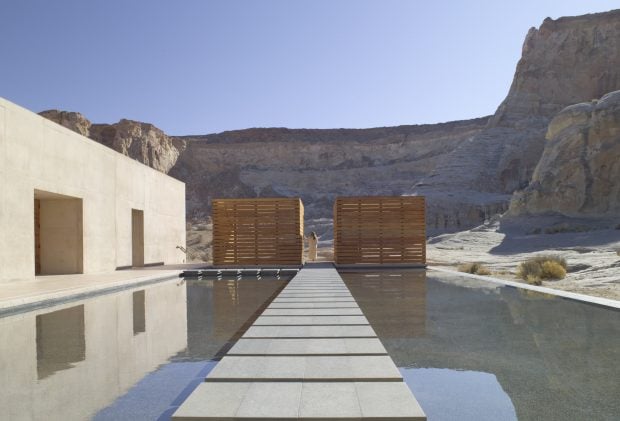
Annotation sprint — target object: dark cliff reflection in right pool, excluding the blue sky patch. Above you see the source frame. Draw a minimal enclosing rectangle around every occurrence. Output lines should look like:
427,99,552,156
343,274,620,420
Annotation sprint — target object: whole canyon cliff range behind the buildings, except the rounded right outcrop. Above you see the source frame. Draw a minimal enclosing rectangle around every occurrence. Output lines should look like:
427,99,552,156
38,11,620,233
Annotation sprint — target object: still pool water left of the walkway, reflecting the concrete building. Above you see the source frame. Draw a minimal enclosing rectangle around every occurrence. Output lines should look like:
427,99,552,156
0,278,286,421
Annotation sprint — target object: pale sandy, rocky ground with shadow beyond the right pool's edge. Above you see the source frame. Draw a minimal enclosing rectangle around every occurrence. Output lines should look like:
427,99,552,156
427,220,620,300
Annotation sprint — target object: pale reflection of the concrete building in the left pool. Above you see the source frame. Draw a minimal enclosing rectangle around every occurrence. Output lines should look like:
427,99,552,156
0,280,187,420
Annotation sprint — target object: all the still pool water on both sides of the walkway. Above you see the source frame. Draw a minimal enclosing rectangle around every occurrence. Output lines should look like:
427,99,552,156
0,271,620,421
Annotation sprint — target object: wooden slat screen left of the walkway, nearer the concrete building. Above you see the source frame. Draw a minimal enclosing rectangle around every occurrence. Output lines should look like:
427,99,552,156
212,198,304,266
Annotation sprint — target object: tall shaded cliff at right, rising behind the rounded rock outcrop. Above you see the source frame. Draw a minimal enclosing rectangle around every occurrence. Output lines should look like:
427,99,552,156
419,11,620,200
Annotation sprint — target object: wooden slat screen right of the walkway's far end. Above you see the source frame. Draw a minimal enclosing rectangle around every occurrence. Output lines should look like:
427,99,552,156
334,196,426,265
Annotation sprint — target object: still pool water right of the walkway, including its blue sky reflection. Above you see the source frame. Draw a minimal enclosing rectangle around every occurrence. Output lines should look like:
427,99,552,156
341,271,620,421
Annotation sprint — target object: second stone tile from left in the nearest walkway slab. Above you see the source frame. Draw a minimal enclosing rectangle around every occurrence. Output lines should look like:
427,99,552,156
234,382,302,419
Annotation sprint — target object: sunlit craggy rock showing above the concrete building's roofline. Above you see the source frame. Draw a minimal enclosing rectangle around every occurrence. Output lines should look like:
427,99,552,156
39,110,185,173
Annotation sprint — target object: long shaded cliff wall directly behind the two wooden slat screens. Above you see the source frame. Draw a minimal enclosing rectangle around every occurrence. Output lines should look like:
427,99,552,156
170,118,490,229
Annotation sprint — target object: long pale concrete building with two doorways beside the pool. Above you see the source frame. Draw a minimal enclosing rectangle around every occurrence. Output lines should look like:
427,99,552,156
0,98,185,282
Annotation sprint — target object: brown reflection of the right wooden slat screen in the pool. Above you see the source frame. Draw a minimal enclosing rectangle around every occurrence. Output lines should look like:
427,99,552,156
340,269,426,338
